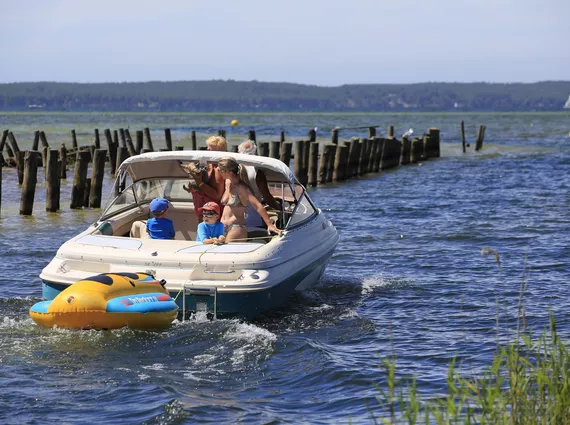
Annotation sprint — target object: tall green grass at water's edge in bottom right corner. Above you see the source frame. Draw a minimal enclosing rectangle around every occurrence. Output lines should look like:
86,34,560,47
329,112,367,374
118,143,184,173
372,260,570,425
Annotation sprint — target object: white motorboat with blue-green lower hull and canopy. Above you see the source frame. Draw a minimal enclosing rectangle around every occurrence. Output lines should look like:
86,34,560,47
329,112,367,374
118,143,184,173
40,151,339,318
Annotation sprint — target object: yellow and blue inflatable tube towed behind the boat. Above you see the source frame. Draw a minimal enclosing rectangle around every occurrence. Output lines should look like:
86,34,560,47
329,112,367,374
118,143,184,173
30,273,178,329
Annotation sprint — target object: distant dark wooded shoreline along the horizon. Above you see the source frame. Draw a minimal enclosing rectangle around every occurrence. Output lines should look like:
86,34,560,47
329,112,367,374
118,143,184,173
0,80,570,112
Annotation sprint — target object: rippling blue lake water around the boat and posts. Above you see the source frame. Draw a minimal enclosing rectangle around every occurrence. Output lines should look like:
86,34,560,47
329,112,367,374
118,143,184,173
0,113,570,424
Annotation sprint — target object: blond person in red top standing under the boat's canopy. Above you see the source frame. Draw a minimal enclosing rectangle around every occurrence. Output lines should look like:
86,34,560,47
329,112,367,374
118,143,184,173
183,136,228,221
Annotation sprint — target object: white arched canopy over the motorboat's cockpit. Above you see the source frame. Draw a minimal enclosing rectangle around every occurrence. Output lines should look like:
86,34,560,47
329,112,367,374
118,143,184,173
117,150,295,184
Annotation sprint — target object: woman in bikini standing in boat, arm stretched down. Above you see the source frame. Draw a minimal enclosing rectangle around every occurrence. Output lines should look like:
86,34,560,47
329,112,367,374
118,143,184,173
218,158,281,242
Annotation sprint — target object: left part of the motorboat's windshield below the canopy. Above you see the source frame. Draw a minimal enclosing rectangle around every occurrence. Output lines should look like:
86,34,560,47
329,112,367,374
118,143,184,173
101,178,192,220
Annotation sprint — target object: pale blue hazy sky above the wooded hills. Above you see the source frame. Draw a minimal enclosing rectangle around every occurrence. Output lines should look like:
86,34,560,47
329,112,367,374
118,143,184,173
0,0,570,86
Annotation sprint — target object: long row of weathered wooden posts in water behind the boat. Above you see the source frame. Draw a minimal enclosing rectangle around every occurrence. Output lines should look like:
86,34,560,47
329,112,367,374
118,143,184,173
0,126,440,215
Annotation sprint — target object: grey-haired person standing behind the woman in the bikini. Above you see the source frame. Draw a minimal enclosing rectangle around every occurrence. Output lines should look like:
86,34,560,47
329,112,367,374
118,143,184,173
238,140,281,227
